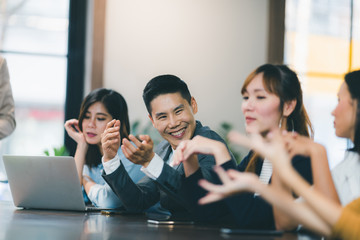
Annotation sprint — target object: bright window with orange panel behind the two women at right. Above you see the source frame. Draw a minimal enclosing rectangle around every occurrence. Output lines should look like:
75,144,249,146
284,0,360,168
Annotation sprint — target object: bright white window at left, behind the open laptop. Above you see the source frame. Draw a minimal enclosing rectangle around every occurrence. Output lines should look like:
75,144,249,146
0,0,69,178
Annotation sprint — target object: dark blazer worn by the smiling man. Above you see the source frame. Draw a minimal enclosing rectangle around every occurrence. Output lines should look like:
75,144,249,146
103,121,236,216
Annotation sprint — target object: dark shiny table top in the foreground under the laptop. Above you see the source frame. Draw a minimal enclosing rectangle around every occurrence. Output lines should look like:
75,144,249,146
0,202,319,240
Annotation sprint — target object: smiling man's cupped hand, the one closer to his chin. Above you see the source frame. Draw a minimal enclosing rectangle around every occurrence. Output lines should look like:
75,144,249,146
121,134,155,167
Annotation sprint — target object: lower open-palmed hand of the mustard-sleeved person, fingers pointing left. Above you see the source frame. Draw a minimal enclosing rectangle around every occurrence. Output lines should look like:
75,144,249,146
199,166,262,204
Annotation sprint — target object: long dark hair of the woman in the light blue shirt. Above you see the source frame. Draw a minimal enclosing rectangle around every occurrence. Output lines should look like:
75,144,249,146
79,88,130,168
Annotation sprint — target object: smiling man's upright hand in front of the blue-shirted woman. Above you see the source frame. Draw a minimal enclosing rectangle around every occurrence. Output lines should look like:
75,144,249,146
101,119,120,162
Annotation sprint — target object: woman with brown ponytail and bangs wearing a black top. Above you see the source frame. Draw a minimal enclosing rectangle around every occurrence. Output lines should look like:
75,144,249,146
175,64,316,229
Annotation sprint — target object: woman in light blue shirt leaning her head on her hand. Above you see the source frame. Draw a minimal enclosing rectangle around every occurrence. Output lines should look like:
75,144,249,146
65,88,144,208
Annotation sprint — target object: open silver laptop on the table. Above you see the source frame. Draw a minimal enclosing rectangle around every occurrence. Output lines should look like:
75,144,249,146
3,155,101,211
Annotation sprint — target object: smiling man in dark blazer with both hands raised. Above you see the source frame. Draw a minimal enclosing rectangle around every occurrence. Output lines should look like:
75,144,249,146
102,75,236,219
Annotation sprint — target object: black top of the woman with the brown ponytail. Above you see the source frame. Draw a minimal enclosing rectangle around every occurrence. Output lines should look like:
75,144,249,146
185,151,313,229
